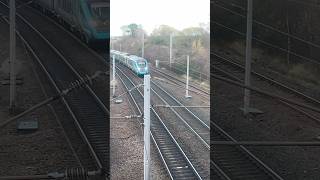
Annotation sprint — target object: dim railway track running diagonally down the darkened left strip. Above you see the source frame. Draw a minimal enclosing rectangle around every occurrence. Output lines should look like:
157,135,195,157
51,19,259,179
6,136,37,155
0,1,109,176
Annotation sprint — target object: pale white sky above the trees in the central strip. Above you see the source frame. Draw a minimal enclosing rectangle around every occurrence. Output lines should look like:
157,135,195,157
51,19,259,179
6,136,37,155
110,0,210,36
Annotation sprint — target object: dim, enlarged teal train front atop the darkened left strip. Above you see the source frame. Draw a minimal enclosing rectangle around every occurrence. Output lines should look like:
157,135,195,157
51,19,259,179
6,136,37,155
33,0,110,45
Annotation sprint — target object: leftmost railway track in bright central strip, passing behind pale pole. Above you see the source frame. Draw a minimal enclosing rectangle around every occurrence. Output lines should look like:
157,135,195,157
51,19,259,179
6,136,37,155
117,64,202,179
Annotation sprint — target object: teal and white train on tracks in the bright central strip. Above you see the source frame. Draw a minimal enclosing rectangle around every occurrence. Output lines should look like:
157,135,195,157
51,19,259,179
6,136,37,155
110,50,149,77
